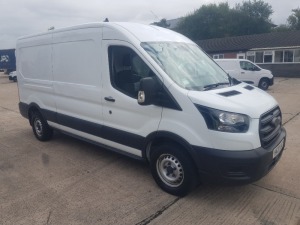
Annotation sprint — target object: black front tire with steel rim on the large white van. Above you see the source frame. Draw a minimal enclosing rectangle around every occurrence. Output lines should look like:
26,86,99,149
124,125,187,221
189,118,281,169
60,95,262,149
150,143,198,196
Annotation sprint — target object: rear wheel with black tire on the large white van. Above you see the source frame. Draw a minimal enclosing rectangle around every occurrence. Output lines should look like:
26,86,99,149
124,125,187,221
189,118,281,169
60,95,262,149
31,112,53,141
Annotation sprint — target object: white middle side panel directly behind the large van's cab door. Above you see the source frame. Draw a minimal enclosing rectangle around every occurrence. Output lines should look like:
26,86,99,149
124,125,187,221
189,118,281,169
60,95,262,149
53,28,102,126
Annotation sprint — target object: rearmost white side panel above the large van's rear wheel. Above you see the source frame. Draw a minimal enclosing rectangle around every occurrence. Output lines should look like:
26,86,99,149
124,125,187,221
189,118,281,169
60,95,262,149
16,34,56,117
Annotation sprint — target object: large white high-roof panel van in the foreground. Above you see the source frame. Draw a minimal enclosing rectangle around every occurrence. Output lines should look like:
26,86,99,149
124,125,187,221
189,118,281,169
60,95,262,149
16,22,286,196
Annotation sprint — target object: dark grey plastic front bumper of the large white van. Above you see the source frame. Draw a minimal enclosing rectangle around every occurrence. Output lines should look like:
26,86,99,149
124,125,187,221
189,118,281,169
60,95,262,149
193,127,286,184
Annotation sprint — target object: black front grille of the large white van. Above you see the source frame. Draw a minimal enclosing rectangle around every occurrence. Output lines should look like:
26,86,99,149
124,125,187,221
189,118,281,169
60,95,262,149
259,107,282,148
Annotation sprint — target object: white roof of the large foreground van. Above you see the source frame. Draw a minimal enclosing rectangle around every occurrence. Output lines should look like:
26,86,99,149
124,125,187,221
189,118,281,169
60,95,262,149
19,22,193,43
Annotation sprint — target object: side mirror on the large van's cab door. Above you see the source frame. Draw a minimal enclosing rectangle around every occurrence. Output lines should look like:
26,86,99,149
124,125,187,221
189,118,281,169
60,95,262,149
138,77,158,105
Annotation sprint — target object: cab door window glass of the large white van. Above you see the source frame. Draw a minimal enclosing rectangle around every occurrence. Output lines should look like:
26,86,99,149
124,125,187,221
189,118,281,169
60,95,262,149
108,46,154,98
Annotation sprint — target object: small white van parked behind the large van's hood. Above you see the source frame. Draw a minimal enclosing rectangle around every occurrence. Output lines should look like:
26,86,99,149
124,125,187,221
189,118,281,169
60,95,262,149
215,59,274,90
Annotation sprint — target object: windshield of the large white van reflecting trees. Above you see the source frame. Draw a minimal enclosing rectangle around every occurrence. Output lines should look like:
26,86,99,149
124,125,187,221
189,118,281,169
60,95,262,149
141,42,229,91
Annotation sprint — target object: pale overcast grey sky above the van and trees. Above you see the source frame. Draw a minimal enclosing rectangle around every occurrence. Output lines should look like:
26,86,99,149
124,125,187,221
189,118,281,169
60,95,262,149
0,0,300,49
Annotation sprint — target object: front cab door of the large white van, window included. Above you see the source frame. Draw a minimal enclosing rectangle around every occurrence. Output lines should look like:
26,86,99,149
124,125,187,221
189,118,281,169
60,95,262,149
102,40,162,156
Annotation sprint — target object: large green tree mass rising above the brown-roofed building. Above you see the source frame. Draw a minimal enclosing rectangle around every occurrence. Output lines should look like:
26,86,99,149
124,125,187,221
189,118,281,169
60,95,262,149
175,0,274,40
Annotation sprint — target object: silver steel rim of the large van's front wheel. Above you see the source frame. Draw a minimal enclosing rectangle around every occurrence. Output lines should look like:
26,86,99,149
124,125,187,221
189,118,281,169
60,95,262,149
156,154,184,187
